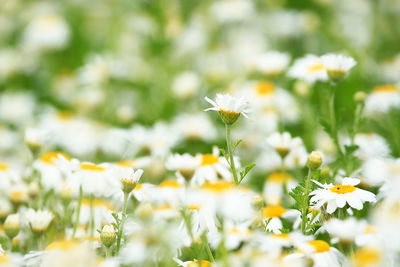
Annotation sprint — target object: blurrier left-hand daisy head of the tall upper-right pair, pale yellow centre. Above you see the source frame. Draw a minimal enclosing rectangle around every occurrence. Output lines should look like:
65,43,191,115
288,55,328,84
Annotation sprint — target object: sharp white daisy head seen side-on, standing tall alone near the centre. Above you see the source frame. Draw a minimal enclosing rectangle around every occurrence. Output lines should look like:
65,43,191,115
204,94,248,124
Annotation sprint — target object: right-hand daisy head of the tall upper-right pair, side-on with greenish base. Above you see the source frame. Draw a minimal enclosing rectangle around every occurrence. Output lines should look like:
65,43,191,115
321,54,357,81
